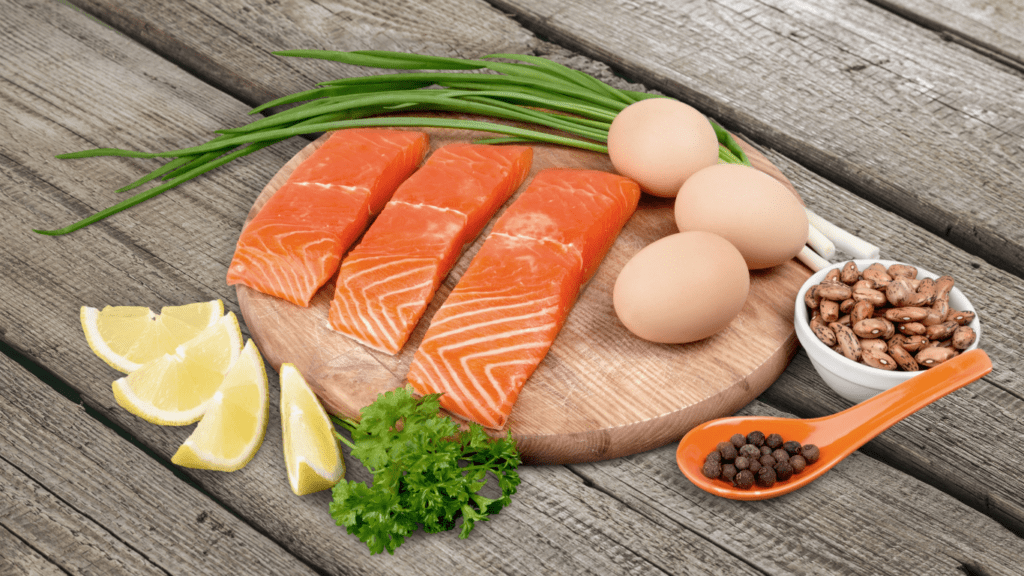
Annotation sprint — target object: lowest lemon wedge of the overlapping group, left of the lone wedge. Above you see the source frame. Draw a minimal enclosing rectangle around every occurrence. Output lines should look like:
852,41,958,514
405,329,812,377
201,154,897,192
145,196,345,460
171,340,270,472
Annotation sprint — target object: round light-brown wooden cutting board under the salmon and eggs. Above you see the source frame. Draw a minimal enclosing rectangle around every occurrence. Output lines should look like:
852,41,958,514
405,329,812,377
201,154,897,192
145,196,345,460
238,119,811,463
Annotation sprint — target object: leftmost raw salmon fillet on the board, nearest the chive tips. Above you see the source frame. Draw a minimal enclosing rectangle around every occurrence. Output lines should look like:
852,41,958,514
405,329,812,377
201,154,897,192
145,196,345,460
227,128,428,306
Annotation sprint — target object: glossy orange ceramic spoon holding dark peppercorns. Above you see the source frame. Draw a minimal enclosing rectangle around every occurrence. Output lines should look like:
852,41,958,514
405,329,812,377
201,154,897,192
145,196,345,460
676,349,992,500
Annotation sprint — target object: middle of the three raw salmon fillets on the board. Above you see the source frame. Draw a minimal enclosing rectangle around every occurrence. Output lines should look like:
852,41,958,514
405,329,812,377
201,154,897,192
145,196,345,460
330,142,534,355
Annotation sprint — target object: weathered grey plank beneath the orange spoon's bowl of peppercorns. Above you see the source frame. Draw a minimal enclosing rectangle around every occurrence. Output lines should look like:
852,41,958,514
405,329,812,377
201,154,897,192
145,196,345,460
570,402,1024,576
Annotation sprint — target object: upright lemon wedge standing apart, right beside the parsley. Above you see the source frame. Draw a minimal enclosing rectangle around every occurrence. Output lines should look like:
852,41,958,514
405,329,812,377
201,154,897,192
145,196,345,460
281,363,345,496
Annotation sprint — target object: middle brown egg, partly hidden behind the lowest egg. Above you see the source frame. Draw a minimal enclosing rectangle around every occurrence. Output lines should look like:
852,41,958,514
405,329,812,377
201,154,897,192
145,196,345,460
675,164,808,270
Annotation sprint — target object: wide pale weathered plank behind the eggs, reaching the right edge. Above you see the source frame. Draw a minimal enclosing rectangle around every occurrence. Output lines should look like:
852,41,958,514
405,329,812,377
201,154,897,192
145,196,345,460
483,0,1024,275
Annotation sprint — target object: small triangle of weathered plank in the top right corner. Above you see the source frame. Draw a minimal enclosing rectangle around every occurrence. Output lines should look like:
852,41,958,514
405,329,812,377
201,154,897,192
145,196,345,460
871,0,1024,70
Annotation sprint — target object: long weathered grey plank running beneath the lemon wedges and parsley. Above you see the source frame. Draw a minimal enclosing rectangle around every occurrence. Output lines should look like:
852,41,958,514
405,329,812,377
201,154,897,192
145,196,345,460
0,2,774,575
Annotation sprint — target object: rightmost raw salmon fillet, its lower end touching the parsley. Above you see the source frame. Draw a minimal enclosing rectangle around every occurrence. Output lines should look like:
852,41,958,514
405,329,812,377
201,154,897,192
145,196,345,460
408,169,640,428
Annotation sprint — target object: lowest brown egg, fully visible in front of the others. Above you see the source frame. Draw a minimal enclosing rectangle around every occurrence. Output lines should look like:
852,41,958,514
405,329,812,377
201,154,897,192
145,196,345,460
612,232,751,343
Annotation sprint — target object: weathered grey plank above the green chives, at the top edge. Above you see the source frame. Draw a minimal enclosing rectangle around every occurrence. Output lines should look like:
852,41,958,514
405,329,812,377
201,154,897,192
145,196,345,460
70,0,535,106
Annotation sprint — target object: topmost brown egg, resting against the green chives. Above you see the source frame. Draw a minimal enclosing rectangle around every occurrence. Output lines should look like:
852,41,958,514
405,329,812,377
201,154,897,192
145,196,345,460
608,97,718,198
